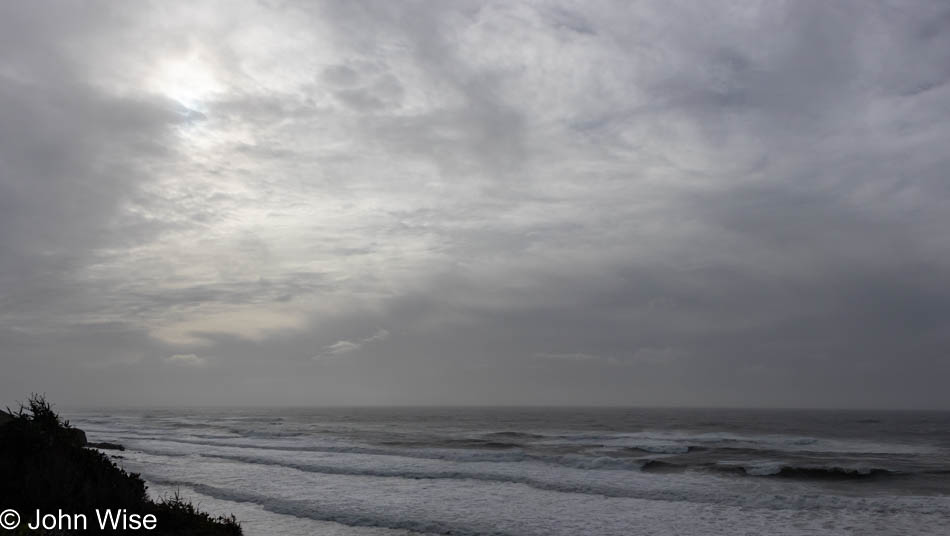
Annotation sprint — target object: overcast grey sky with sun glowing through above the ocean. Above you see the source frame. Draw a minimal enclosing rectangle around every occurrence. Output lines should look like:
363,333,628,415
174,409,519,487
0,0,950,408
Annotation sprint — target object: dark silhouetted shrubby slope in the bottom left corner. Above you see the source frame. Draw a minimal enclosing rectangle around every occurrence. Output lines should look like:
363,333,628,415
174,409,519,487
0,395,242,536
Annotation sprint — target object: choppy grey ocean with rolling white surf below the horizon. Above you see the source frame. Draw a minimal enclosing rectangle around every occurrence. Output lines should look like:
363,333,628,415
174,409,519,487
66,408,950,536
